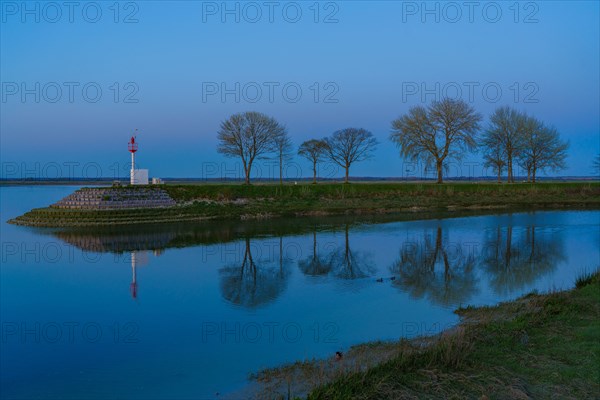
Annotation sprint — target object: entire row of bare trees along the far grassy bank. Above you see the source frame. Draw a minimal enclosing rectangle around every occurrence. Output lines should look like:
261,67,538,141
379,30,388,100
218,99,568,184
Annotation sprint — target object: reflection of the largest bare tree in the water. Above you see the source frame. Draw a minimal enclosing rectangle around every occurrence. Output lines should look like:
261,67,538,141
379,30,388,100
390,226,478,306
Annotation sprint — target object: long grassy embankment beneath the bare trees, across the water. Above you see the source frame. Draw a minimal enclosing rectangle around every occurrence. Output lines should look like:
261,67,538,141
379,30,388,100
8,182,600,226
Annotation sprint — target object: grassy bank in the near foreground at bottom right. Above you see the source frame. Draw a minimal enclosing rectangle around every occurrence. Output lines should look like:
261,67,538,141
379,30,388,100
255,272,600,399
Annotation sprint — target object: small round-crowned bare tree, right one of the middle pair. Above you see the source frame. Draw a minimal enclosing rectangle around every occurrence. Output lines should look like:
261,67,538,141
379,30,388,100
324,128,377,183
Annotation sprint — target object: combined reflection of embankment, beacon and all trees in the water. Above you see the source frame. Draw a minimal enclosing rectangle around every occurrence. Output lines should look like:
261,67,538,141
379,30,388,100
44,214,566,309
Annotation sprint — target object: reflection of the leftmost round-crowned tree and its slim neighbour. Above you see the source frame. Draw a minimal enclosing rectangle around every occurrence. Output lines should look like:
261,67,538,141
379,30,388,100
219,237,289,308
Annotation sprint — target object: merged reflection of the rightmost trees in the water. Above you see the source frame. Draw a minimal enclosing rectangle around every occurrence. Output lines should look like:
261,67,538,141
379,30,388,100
481,225,565,294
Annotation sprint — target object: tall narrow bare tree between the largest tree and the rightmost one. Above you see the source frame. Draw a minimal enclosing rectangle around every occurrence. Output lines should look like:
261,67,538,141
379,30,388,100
484,107,525,183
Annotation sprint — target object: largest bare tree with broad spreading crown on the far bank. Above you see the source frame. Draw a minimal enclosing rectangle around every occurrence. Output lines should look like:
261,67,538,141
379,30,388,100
390,99,481,183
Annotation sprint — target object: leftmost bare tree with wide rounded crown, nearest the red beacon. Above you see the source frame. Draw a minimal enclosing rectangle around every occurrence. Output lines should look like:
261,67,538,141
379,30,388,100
217,112,285,184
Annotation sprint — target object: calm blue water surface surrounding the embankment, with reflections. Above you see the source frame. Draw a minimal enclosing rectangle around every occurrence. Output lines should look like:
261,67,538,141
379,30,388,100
0,186,600,399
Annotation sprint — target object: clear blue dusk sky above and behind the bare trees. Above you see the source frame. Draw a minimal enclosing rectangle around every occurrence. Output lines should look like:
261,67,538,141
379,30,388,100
0,1,600,178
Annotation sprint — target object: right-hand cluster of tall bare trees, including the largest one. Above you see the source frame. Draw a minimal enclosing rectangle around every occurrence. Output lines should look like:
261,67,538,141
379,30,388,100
390,99,568,183
